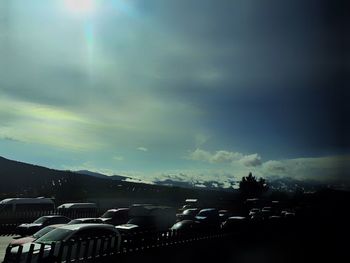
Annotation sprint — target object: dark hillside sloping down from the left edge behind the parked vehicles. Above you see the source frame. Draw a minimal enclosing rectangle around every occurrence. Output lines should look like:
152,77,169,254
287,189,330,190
0,157,237,207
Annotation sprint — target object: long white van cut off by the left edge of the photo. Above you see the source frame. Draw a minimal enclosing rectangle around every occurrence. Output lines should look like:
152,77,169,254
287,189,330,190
0,197,55,212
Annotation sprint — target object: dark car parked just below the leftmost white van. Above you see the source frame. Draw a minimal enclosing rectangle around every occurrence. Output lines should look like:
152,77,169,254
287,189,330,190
16,215,71,236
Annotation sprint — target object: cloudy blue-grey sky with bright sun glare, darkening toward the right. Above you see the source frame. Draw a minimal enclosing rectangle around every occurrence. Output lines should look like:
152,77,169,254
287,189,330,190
0,0,350,188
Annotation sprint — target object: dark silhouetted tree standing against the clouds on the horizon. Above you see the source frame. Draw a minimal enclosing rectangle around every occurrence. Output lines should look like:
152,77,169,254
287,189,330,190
239,173,269,198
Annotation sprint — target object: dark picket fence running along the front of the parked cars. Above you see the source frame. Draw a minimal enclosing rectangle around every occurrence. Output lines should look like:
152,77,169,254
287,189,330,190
4,230,230,263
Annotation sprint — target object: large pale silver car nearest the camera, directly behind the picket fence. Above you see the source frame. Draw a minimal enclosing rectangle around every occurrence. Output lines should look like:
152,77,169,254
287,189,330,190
6,224,120,263
